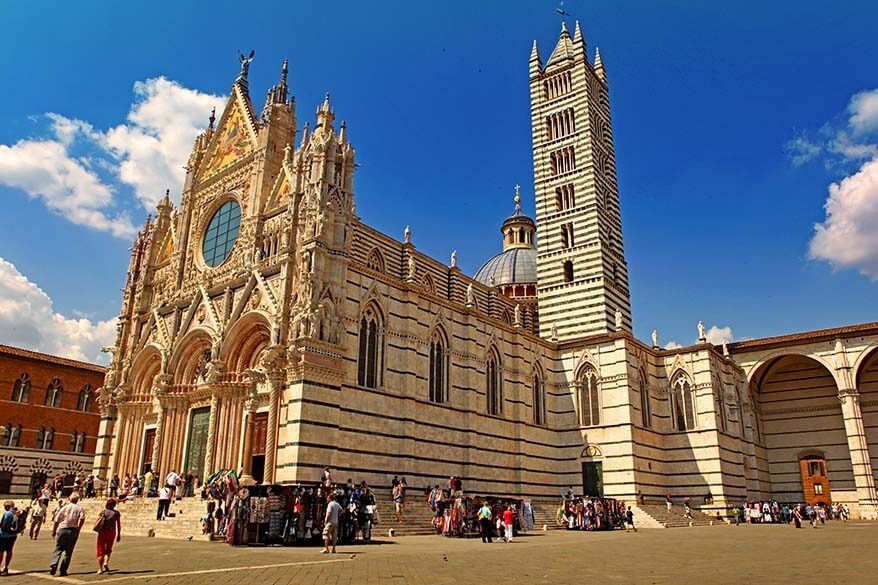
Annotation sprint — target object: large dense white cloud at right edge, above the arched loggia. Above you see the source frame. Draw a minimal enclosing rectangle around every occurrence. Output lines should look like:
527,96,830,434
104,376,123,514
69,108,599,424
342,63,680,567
808,158,878,281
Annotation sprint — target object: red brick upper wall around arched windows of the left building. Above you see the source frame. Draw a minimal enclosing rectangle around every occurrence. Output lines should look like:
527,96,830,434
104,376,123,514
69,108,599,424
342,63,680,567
0,347,104,453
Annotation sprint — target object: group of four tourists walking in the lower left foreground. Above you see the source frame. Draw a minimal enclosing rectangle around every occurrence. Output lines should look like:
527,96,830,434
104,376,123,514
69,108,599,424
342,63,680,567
0,492,122,577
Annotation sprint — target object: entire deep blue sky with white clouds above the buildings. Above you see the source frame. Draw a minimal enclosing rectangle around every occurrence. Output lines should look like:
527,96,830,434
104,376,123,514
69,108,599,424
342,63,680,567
0,0,878,359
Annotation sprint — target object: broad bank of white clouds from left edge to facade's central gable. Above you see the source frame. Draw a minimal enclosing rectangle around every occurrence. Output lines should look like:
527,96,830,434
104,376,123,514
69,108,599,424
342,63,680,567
0,77,225,239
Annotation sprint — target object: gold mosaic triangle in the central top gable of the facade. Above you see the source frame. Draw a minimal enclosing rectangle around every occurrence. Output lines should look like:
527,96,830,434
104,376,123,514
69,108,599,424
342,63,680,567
199,85,256,180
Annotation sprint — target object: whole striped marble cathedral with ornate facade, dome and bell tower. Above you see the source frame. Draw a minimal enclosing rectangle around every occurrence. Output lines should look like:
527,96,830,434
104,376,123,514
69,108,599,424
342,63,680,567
94,24,878,518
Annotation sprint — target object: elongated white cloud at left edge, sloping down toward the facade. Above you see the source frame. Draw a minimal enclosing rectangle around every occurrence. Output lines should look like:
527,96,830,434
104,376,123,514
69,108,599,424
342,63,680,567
0,140,135,238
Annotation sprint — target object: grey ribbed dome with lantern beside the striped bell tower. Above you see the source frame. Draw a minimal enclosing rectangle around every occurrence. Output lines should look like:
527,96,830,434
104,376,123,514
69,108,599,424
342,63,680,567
473,185,537,287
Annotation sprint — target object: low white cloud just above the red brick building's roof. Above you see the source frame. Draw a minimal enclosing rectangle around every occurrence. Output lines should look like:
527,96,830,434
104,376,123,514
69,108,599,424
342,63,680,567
0,257,116,363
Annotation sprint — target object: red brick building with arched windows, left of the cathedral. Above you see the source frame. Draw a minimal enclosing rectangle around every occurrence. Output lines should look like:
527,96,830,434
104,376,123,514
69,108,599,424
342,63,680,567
0,345,105,494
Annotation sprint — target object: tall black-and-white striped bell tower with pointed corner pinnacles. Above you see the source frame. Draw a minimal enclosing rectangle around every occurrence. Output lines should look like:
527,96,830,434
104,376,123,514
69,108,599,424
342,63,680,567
529,23,631,341
